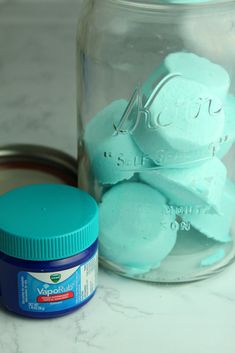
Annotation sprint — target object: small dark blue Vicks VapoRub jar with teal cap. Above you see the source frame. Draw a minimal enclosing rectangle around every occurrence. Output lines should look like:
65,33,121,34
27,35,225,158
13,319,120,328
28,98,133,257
0,184,98,318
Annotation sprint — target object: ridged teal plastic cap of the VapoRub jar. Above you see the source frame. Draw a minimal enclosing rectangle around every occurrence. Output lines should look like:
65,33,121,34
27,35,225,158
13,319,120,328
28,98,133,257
0,184,98,261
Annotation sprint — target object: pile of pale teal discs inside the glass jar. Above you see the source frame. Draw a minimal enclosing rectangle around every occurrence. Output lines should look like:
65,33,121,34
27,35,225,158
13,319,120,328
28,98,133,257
85,52,235,275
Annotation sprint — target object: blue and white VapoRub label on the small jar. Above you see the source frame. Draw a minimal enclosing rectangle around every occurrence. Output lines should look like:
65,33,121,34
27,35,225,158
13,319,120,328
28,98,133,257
18,253,98,312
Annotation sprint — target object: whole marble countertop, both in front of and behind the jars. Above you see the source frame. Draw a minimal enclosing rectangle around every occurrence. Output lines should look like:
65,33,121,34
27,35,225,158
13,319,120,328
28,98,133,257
0,0,235,353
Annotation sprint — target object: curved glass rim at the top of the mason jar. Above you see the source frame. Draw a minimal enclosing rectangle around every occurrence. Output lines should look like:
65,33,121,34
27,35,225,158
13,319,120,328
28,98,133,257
103,0,235,12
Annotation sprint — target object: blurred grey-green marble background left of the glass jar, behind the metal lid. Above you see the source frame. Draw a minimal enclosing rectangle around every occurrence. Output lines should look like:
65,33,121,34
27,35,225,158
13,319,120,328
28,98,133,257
0,0,80,155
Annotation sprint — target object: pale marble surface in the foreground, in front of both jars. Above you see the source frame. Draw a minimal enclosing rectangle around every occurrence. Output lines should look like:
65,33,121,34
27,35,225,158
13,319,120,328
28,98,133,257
0,266,235,353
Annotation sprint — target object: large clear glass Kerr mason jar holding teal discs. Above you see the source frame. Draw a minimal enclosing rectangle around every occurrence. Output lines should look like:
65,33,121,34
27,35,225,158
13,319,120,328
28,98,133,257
77,0,235,283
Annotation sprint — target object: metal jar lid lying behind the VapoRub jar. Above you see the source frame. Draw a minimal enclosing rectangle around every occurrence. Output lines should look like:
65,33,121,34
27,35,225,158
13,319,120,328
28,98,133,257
0,144,77,195
